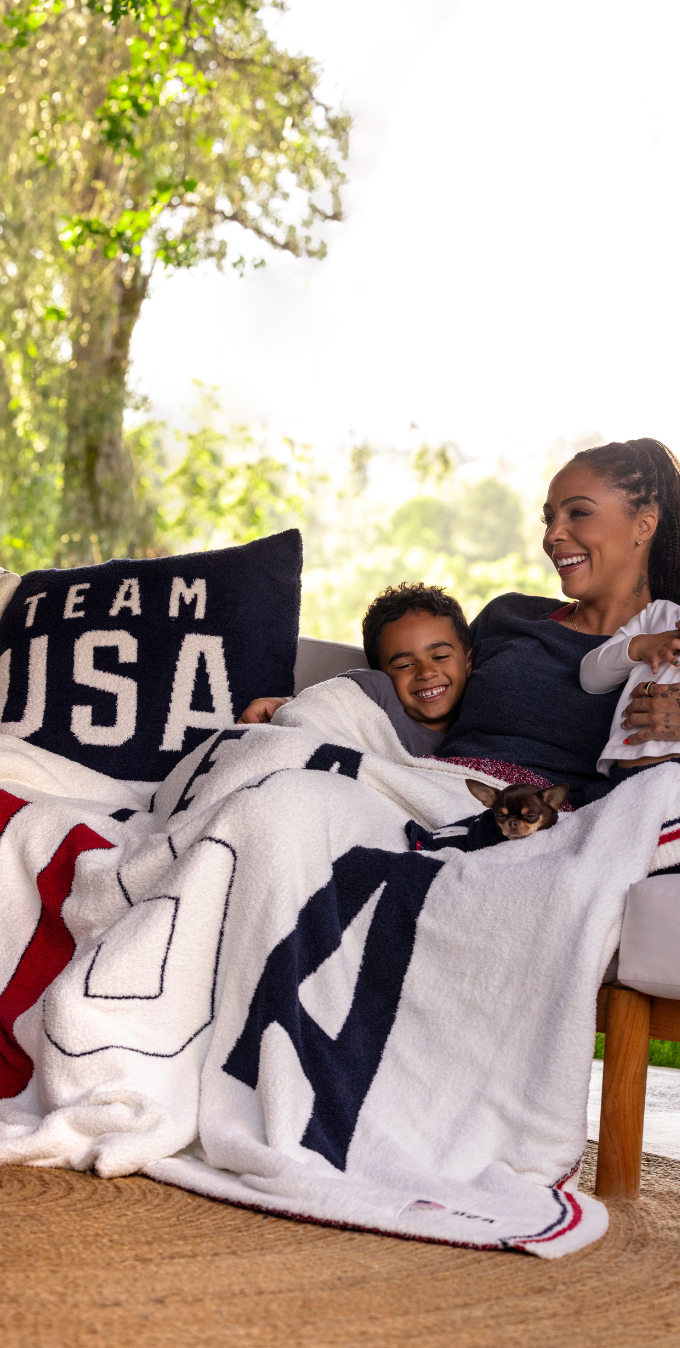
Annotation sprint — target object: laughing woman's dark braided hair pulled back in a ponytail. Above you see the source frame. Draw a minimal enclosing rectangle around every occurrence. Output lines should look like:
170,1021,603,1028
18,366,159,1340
571,439,680,604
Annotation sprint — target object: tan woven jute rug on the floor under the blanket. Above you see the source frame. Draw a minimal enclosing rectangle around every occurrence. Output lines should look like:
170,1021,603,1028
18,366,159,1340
0,1146,680,1348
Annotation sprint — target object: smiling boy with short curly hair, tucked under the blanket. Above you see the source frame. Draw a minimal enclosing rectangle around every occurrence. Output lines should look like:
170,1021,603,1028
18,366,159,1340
240,581,472,758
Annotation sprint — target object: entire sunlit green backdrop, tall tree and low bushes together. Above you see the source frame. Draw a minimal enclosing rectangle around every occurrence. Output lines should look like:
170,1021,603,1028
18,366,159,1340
0,0,557,642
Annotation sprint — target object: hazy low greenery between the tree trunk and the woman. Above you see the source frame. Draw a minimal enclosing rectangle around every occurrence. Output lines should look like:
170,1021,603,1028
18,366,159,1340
124,387,560,642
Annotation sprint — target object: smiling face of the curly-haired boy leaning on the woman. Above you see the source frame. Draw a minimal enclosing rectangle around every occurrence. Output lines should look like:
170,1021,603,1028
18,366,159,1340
379,612,472,731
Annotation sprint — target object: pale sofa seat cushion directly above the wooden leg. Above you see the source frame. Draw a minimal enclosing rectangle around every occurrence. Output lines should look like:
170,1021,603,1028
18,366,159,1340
618,875,680,1000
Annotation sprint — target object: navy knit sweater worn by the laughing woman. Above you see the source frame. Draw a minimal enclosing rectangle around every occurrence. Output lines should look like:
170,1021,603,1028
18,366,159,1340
437,593,621,805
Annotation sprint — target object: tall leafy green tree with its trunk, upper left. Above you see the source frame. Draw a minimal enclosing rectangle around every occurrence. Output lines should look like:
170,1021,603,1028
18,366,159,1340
0,0,348,565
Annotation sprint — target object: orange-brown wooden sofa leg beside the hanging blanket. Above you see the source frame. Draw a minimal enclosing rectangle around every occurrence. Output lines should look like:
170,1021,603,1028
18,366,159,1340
595,988,652,1198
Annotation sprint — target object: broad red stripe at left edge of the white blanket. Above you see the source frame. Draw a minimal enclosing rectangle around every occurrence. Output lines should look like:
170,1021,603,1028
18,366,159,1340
0,814,113,1099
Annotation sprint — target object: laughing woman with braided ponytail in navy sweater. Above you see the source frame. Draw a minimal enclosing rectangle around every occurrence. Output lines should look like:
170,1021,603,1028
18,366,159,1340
242,439,680,806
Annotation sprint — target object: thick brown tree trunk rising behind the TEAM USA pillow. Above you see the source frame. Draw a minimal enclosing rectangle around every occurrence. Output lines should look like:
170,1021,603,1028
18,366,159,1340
55,259,148,566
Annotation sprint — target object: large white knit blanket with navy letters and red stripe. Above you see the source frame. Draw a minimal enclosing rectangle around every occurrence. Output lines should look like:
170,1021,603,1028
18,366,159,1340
0,679,680,1258
